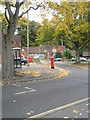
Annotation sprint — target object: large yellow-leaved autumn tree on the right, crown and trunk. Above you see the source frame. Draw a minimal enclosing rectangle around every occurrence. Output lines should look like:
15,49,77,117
48,2,89,63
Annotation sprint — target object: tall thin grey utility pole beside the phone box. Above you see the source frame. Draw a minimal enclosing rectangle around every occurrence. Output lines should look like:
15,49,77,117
27,7,29,67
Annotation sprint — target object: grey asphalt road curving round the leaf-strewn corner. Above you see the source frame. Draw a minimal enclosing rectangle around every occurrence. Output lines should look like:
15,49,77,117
2,63,88,118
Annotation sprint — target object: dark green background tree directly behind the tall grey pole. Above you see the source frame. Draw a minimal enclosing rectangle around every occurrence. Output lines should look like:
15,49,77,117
17,17,40,47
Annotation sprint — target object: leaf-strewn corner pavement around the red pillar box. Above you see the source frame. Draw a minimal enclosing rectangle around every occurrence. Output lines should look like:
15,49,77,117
3,61,67,85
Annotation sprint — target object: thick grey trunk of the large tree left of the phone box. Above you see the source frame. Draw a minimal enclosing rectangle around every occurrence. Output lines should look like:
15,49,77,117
2,23,16,80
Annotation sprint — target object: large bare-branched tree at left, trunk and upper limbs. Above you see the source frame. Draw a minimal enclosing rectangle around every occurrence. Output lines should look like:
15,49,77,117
2,0,40,80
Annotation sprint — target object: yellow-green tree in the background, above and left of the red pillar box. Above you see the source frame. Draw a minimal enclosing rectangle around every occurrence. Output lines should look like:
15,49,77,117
37,19,54,45
